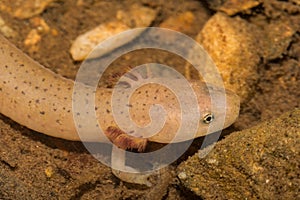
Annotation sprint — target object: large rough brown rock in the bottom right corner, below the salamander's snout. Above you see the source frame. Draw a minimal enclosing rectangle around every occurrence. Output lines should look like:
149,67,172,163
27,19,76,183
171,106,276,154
177,109,300,199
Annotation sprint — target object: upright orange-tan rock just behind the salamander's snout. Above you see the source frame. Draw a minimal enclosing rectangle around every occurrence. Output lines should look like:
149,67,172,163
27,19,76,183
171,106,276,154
196,13,261,103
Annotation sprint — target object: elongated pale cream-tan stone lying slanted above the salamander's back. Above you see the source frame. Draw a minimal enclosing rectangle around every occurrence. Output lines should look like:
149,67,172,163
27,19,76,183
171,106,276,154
70,4,157,61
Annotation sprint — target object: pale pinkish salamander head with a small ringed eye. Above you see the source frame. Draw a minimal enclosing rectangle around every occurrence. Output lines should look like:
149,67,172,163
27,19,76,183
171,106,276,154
117,73,240,143
